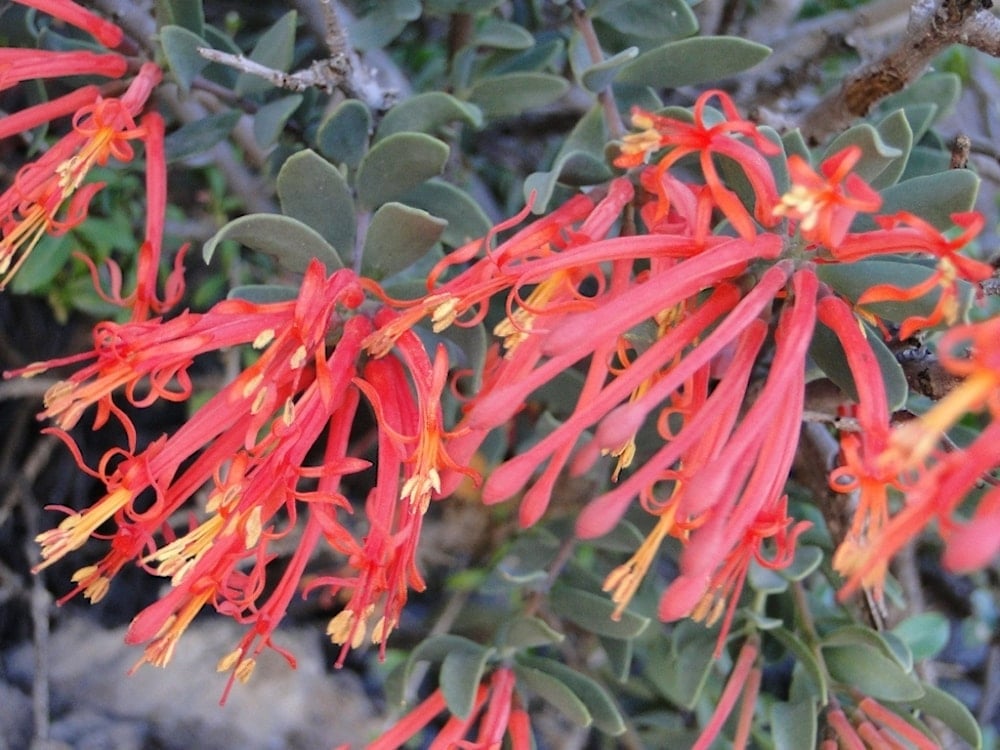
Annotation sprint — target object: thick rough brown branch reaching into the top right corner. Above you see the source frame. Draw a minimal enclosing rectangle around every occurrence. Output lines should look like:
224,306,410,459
801,0,1000,142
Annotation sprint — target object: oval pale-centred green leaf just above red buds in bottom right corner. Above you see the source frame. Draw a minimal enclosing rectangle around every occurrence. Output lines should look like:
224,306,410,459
823,643,924,702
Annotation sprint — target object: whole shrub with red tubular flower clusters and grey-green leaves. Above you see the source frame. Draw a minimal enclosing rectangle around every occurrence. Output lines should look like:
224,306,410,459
0,0,1000,748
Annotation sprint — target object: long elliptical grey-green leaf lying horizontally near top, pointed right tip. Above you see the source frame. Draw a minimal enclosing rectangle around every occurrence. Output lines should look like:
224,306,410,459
617,36,771,88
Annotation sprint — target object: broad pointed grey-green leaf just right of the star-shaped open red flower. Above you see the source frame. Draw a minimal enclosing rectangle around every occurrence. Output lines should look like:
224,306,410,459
851,169,979,232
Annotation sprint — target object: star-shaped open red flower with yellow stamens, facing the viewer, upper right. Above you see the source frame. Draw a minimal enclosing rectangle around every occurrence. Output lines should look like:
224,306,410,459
774,146,882,252
